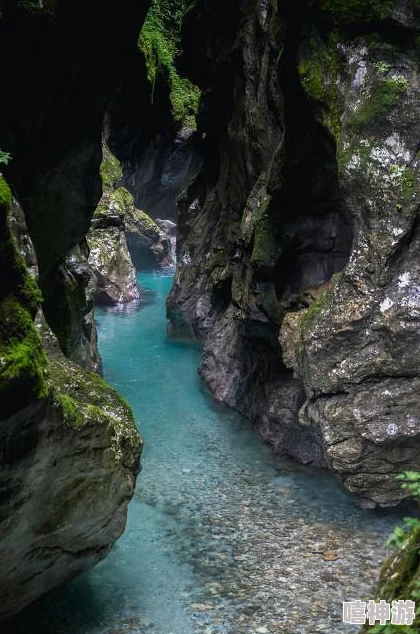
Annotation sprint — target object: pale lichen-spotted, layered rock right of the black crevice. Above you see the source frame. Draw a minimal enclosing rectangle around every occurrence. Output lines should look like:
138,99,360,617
288,22,420,504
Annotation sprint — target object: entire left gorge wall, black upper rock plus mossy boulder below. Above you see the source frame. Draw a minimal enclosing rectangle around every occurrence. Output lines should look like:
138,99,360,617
0,0,148,618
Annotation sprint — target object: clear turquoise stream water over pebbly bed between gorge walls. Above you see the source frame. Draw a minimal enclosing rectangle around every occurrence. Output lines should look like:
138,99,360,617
2,272,397,634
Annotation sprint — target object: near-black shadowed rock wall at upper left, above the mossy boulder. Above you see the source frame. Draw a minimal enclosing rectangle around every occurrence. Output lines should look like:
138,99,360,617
0,0,149,368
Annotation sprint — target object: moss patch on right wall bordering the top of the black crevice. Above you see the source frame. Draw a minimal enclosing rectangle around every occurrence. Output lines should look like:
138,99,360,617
298,31,341,139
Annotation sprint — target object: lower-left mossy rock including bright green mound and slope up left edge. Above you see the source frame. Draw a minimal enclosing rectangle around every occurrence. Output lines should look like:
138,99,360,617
0,178,141,619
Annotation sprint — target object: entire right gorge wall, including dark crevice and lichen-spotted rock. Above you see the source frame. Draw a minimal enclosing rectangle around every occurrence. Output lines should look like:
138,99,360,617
167,0,420,506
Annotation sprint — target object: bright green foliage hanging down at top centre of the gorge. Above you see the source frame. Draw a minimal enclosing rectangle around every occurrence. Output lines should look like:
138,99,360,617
139,0,200,126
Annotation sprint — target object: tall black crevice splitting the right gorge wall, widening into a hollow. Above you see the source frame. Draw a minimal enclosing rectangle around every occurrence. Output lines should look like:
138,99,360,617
269,1,353,308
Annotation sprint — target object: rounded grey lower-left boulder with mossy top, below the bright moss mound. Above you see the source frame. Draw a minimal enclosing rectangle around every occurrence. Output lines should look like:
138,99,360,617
0,314,141,618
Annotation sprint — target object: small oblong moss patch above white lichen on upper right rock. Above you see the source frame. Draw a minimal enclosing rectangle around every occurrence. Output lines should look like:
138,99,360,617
349,77,407,128
